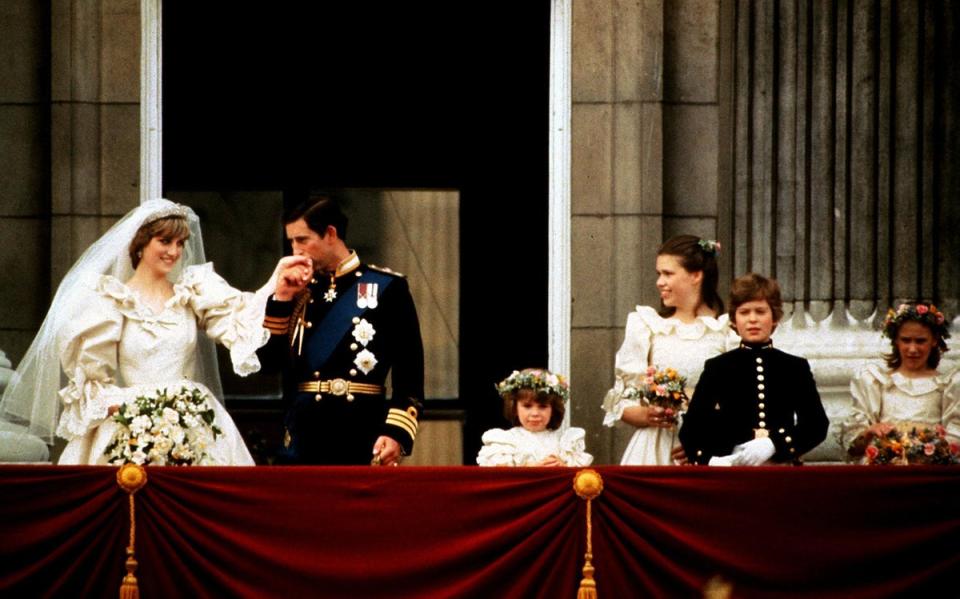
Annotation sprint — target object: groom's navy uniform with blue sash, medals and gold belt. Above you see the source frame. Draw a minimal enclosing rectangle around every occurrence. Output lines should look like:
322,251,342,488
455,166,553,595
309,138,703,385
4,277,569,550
258,254,423,465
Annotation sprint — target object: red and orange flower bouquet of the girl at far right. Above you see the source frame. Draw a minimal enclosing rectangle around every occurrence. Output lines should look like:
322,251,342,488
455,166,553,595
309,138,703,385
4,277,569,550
864,424,960,466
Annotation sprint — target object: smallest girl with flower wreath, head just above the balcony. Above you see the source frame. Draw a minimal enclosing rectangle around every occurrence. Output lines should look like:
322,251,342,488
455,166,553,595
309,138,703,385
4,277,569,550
477,368,593,466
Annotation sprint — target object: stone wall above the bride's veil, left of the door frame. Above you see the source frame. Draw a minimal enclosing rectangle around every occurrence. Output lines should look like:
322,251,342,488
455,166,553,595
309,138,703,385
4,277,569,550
0,0,140,364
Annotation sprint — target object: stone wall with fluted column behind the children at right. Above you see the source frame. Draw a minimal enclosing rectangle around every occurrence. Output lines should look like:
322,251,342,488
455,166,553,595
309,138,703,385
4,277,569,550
571,0,960,463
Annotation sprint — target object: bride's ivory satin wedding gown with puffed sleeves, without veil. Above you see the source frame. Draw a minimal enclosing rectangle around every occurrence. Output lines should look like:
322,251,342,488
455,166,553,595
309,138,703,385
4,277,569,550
57,263,269,466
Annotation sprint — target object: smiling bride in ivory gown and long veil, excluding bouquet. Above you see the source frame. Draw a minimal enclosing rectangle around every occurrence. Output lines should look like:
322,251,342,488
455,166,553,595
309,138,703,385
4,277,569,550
0,199,273,465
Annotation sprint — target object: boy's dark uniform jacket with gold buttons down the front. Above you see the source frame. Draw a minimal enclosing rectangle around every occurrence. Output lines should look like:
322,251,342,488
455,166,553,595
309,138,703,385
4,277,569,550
680,343,829,464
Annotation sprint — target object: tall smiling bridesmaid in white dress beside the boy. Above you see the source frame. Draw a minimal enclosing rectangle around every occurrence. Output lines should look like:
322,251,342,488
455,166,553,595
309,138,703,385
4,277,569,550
603,235,739,466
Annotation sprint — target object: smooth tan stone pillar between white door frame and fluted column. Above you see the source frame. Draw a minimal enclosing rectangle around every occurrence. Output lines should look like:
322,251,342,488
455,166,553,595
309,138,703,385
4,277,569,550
571,0,719,464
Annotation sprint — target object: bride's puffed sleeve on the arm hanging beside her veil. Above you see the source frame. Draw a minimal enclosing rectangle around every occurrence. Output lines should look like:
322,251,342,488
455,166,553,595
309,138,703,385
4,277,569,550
57,296,123,440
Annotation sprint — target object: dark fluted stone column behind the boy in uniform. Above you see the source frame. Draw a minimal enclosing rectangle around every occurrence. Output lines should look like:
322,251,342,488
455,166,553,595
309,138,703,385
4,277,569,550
720,1,960,325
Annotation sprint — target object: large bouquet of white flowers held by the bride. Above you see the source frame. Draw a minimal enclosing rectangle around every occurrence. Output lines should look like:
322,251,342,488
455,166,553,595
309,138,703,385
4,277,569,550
104,387,222,466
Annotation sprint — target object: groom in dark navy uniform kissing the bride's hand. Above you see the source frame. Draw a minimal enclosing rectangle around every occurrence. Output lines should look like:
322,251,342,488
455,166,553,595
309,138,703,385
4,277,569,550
258,197,423,466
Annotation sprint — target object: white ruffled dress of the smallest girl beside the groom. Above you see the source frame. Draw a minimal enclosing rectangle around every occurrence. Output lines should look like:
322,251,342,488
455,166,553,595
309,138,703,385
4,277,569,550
477,426,593,466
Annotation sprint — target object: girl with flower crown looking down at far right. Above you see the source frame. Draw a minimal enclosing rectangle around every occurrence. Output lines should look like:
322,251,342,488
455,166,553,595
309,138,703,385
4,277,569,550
840,301,960,459
